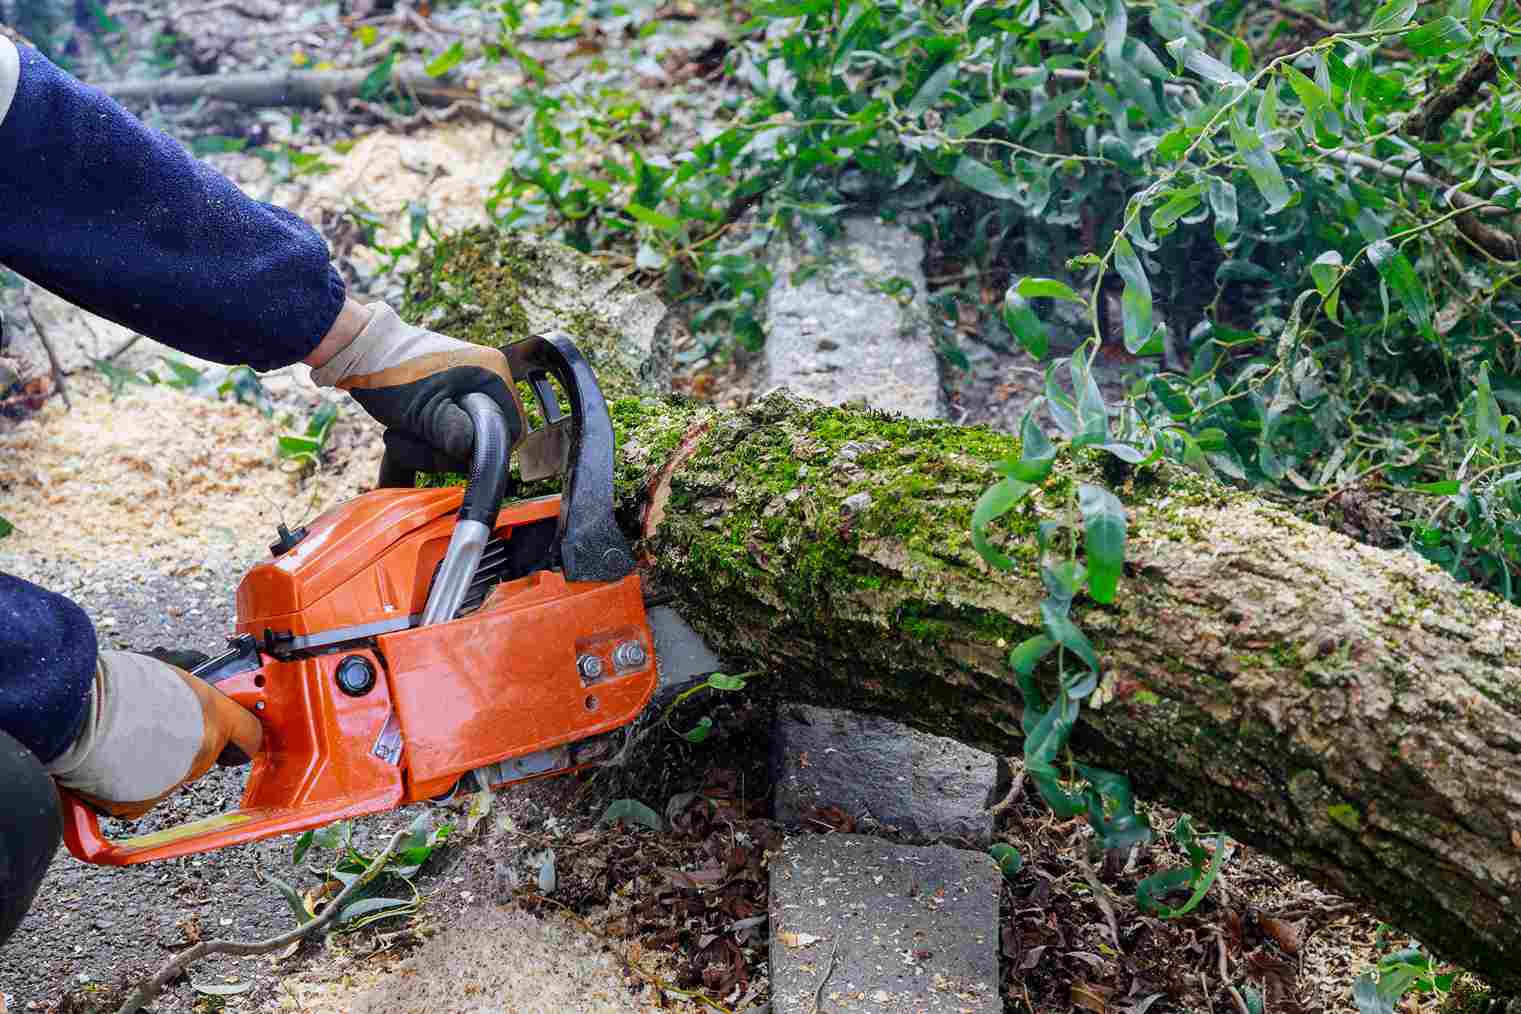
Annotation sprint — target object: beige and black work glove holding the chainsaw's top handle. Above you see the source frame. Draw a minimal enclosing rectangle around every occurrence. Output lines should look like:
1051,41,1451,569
312,303,526,470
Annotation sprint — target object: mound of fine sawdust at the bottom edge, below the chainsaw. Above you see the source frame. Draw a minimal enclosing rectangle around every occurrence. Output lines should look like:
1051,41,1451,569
281,906,649,1014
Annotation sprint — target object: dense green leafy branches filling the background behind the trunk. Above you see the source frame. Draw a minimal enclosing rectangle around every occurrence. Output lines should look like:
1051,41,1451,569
493,0,1521,599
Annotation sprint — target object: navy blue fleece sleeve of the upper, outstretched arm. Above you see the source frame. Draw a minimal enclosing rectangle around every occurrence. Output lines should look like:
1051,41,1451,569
0,47,345,369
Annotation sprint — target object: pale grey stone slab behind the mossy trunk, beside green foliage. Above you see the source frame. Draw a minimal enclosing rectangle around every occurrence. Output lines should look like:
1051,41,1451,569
765,217,945,420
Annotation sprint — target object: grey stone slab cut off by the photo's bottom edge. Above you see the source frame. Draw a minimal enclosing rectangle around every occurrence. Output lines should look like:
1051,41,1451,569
771,835,1002,1014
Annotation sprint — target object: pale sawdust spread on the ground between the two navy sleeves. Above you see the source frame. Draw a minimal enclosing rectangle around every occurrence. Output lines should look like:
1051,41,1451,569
0,374,382,576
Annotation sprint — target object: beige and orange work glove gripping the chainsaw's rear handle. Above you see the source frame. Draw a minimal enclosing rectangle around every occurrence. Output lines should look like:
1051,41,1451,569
46,651,263,819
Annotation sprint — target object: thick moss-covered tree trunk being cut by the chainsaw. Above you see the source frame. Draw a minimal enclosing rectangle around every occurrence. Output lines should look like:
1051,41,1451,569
411,233,1521,991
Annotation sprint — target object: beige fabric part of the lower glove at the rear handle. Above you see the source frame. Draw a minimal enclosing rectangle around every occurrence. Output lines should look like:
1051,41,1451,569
47,651,205,801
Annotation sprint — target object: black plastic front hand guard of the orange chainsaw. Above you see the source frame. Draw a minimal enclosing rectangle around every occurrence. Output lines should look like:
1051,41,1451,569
505,331,634,581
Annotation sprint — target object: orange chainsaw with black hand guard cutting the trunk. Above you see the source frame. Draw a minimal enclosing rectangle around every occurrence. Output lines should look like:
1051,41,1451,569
62,334,718,865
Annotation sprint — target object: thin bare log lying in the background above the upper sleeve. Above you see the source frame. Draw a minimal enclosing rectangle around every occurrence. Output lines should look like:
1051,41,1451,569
94,67,478,106
